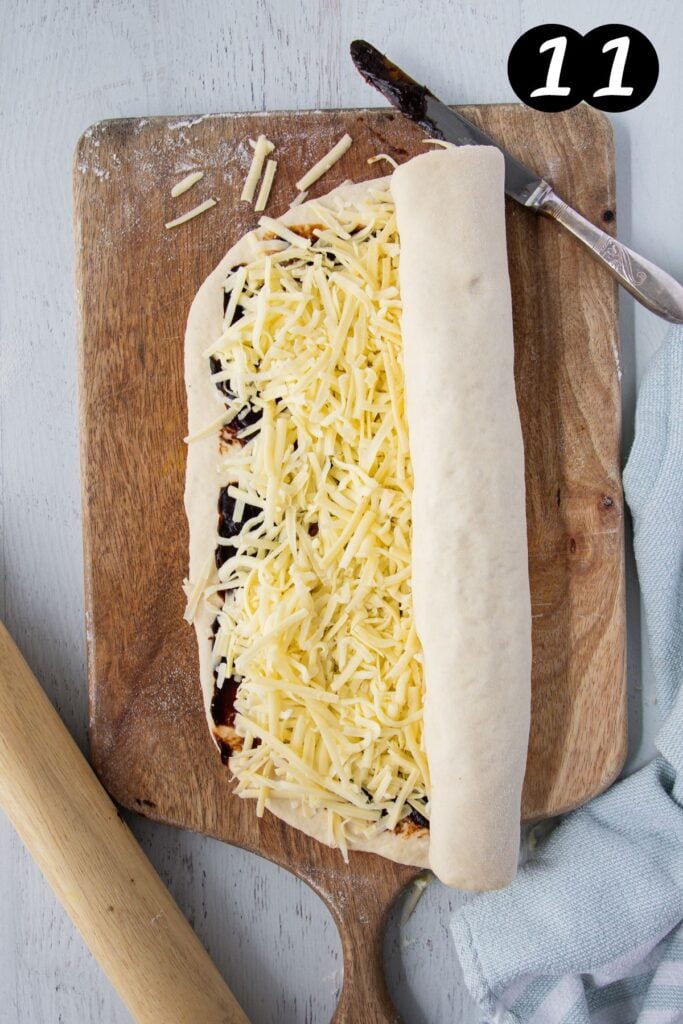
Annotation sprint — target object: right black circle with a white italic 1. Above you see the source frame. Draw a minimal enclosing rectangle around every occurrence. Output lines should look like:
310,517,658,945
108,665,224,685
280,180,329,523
584,25,659,113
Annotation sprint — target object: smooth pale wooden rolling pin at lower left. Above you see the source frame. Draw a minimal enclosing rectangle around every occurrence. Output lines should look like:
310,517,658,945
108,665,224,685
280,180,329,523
0,623,249,1024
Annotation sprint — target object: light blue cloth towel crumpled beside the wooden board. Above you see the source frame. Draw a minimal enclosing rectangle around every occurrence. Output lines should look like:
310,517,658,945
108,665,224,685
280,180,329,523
453,328,683,1024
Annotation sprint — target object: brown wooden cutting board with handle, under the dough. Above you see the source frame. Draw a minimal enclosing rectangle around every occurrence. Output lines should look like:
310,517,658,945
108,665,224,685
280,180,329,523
74,105,626,1024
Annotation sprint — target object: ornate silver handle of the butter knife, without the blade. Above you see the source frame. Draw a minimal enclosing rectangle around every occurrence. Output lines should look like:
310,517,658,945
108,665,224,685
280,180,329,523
525,181,683,324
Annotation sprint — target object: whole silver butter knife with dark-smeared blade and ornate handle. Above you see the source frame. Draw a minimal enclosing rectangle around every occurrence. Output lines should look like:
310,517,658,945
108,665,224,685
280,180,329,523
351,39,683,324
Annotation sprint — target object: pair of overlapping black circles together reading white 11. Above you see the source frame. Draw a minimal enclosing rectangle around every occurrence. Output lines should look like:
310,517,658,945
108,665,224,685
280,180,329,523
508,25,659,113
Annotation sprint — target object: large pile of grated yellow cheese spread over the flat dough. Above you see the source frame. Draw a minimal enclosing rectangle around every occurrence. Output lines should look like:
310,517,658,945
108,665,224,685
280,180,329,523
186,183,429,854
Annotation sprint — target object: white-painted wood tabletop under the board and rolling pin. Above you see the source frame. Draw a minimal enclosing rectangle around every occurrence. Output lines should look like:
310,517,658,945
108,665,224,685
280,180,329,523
0,0,683,1024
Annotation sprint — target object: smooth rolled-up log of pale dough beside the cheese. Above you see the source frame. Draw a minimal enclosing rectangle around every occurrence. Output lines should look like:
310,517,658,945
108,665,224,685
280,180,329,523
391,146,531,889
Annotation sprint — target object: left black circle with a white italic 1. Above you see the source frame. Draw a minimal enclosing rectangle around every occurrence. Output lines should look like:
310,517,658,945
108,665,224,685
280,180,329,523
508,25,584,113
